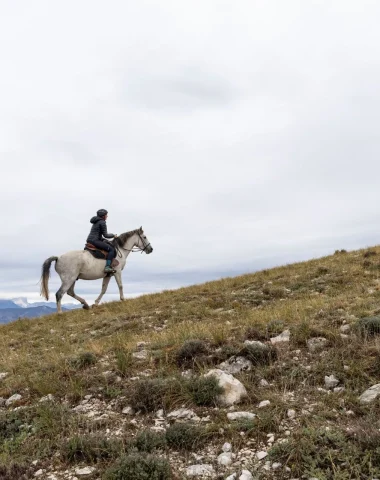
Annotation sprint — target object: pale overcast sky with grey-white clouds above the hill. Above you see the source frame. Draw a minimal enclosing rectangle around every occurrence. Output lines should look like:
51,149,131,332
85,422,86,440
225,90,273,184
0,0,380,302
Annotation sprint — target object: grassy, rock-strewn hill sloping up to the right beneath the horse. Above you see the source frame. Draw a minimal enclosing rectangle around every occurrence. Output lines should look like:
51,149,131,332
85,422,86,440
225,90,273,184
0,247,380,480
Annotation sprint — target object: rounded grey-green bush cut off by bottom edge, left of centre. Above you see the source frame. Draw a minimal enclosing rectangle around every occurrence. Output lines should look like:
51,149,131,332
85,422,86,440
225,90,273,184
104,453,173,480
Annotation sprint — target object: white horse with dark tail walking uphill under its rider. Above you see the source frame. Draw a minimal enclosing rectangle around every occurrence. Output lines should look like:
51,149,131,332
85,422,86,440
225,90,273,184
41,227,153,313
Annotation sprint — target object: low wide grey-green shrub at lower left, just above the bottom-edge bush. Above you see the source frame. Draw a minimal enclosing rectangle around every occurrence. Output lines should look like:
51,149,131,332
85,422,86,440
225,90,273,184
61,436,123,463
